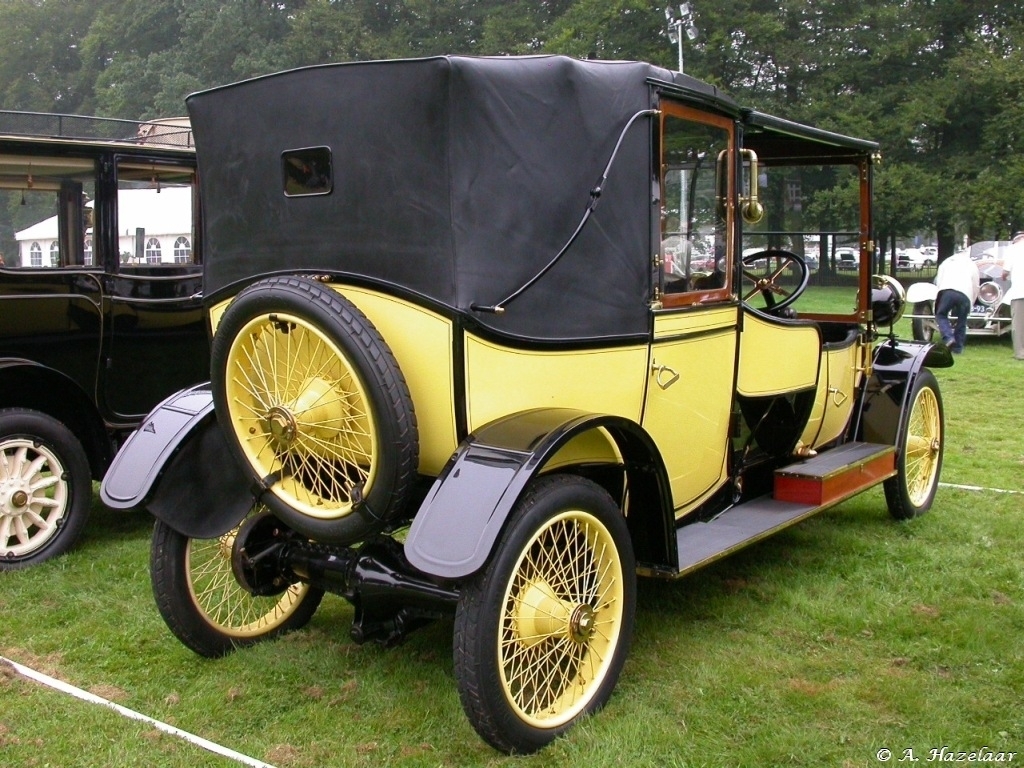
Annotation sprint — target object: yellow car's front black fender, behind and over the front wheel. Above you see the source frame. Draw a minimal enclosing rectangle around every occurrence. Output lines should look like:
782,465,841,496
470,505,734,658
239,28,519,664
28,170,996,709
855,339,953,445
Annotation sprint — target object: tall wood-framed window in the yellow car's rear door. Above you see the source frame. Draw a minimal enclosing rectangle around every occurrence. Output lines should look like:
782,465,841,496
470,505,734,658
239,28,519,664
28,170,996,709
660,108,732,304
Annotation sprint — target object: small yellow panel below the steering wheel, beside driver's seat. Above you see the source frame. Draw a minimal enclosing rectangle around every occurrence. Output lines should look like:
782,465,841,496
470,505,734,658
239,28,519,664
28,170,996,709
736,312,821,397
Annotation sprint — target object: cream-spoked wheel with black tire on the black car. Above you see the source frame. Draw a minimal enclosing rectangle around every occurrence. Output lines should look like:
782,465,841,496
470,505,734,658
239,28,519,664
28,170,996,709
0,409,92,570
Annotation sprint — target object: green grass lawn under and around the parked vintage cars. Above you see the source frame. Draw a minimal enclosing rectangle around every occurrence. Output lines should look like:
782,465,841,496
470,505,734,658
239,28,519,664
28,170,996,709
0,331,1024,768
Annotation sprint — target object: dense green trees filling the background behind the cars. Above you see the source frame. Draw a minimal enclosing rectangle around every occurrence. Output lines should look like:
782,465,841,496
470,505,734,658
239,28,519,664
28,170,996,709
0,0,1024,253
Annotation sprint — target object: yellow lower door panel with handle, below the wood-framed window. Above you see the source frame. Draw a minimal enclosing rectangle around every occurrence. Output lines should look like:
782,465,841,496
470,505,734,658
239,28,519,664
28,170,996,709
643,306,739,515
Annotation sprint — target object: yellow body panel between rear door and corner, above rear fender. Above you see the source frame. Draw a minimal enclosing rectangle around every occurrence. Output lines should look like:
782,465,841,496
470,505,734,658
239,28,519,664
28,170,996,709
466,334,647,431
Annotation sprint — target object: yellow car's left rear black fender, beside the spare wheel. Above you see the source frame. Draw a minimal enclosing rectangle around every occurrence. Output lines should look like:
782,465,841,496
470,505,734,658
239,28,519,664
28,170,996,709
99,383,253,539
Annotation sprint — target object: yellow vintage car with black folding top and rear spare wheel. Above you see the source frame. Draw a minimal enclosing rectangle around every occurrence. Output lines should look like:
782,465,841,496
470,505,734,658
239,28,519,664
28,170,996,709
102,56,951,753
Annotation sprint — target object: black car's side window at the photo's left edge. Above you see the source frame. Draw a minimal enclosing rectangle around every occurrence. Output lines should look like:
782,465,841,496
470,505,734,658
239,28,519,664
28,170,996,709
0,155,96,269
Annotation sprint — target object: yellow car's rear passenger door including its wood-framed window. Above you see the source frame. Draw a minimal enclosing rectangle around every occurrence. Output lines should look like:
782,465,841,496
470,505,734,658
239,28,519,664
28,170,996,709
643,102,739,515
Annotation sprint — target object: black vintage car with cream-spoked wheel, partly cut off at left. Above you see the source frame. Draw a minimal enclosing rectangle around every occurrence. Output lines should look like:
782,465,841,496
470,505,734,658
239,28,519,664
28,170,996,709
0,112,209,570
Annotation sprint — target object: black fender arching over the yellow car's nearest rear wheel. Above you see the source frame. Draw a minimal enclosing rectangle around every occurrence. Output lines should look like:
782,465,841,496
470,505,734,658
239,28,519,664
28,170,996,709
406,409,675,579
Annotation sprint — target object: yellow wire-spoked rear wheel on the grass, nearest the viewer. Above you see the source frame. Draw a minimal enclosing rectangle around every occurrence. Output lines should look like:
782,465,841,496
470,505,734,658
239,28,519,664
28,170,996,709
454,475,636,754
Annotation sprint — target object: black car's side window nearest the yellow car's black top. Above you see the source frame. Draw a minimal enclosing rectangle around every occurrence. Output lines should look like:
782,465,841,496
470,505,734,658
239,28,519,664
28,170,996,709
118,158,199,268
